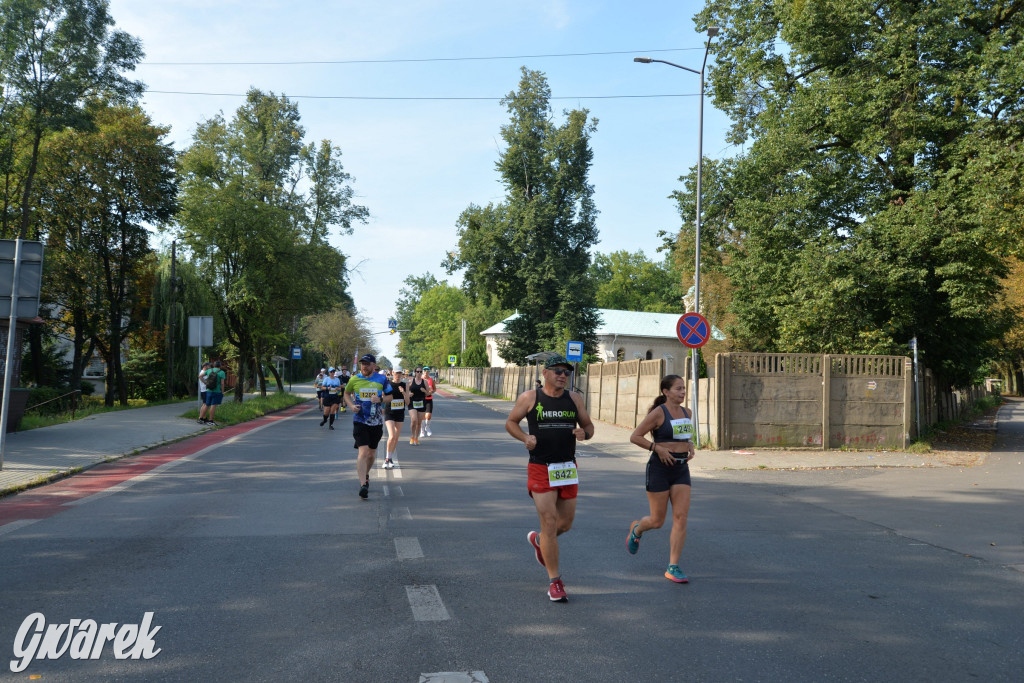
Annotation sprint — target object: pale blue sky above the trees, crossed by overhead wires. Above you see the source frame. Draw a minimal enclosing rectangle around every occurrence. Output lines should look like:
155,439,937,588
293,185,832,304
111,0,734,368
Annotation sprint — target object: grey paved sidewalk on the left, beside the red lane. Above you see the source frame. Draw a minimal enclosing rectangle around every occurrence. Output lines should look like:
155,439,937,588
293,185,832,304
0,385,313,496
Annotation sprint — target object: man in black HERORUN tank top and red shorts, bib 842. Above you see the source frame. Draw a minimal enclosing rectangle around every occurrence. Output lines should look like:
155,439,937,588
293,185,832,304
505,355,594,602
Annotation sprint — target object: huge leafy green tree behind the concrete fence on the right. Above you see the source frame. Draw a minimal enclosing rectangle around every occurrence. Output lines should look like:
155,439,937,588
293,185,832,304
682,0,1024,384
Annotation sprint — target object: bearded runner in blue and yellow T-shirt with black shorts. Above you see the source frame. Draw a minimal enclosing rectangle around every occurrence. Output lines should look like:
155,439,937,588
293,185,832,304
345,353,393,500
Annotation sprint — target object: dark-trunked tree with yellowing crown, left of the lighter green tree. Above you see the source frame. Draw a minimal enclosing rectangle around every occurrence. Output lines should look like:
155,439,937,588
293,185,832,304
38,104,175,405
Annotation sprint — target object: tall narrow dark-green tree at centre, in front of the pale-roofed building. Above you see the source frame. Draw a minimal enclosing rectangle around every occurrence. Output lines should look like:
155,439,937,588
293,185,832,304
445,68,598,362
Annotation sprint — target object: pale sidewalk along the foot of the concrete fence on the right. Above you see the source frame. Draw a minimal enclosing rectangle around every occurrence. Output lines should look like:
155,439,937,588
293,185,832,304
439,384,986,471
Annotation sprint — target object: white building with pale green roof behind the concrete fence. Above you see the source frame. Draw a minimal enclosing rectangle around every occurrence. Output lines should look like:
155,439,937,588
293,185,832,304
480,308,725,373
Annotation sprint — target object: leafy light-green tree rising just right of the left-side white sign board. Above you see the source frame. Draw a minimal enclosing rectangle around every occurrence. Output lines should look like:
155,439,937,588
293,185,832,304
179,89,368,400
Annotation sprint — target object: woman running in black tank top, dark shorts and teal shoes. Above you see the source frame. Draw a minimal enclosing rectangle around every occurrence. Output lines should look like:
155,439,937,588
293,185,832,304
626,375,694,584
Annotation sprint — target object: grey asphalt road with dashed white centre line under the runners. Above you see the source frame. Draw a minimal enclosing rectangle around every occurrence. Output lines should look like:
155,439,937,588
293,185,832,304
0,399,1024,681
